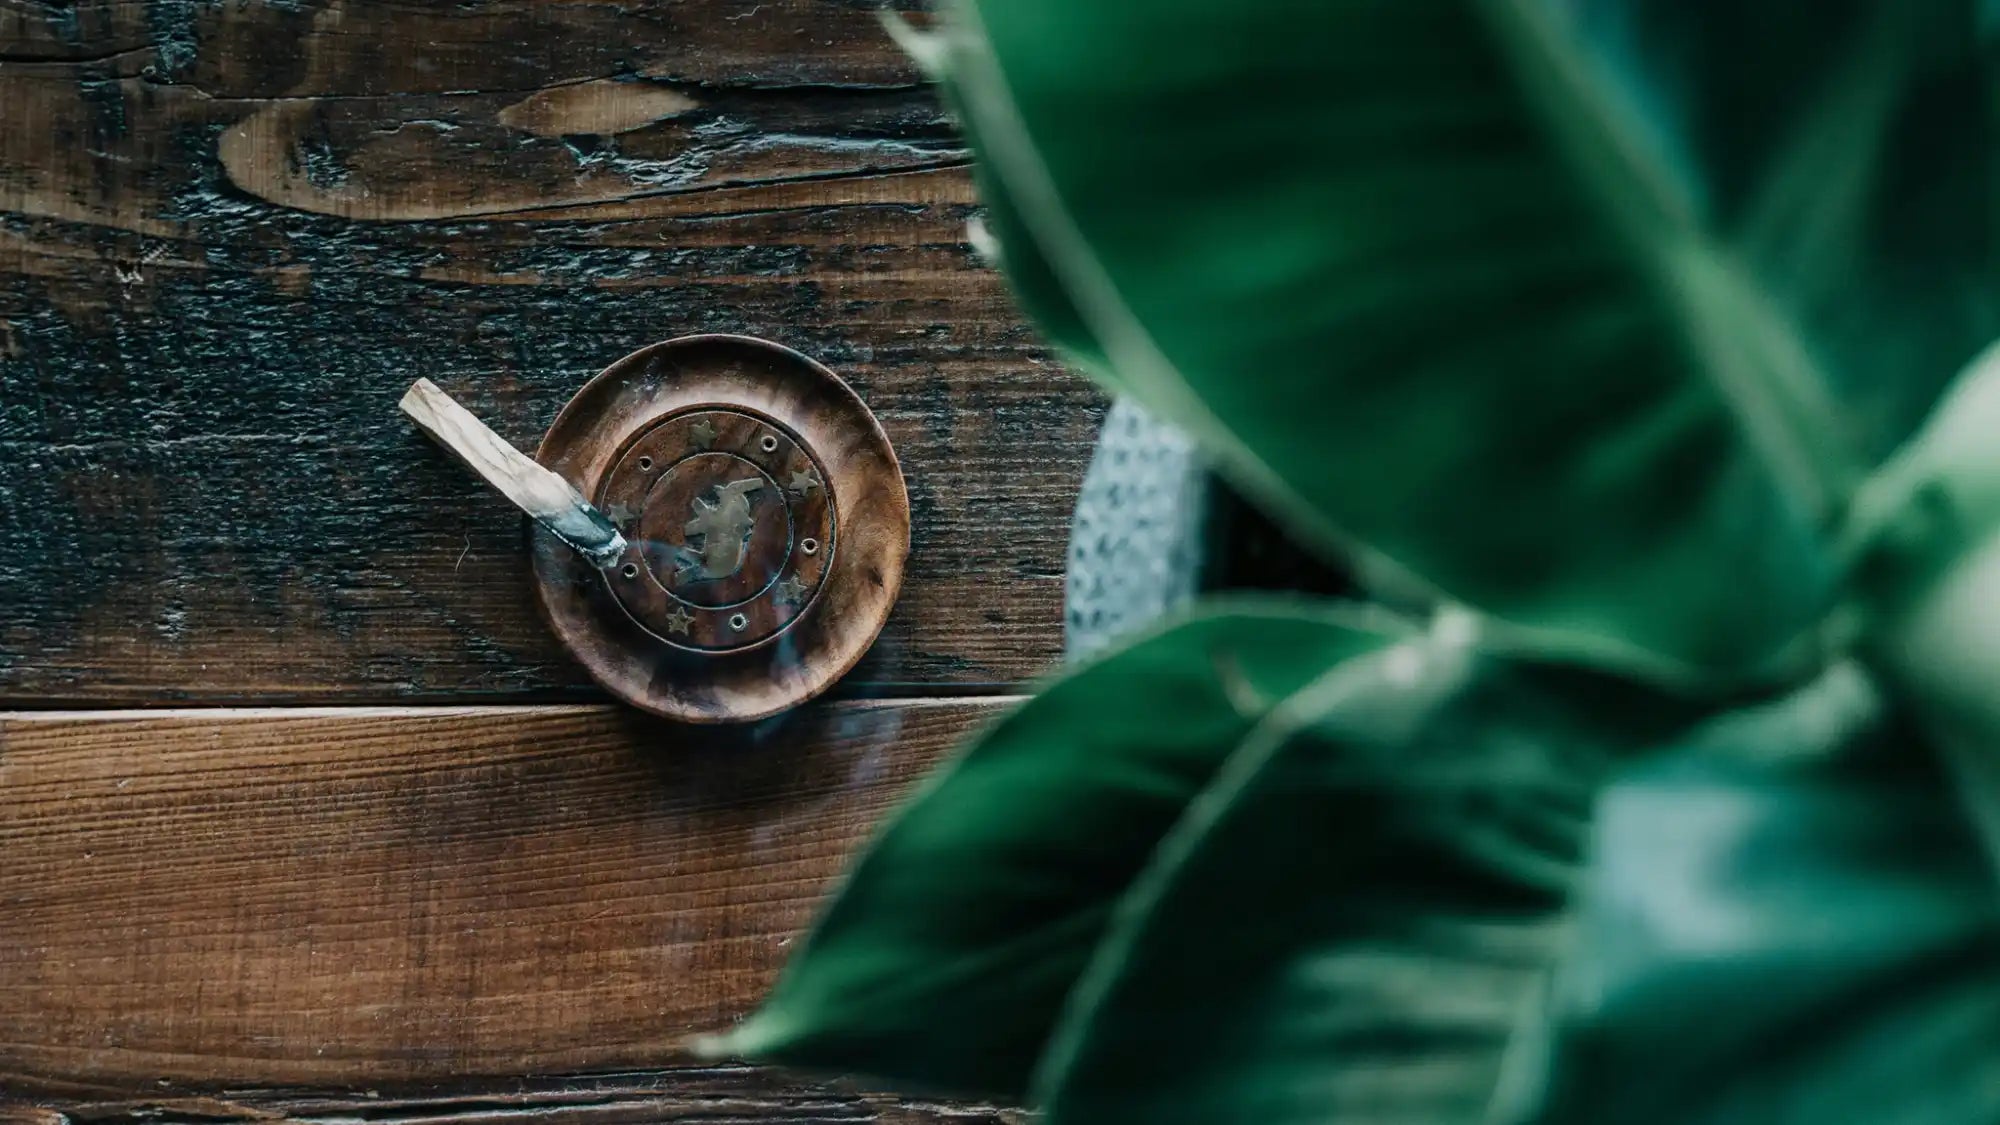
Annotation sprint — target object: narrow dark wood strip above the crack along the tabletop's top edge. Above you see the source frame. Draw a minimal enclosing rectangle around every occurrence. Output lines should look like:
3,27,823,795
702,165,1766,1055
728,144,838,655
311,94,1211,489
0,0,932,90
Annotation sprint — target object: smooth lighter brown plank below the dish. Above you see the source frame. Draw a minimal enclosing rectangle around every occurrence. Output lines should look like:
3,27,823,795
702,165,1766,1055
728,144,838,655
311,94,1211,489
0,701,998,1097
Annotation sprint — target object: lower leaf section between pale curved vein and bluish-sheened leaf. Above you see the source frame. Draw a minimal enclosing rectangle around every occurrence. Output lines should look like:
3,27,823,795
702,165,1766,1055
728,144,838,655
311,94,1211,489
1038,624,1690,1125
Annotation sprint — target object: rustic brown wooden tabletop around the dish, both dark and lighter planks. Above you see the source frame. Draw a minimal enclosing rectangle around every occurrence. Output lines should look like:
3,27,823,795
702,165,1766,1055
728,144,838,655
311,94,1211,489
0,0,1098,1125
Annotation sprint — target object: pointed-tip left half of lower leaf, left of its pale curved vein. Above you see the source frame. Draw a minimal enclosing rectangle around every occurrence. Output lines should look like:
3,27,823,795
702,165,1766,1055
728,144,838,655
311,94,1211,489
708,601,1400,1099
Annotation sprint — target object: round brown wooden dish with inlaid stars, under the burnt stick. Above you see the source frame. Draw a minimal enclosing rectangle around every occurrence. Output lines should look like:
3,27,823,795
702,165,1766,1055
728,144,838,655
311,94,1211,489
530,336,910,723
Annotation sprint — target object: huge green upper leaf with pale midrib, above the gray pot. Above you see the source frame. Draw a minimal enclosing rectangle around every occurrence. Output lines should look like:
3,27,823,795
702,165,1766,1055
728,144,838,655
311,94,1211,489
950,0,2000,683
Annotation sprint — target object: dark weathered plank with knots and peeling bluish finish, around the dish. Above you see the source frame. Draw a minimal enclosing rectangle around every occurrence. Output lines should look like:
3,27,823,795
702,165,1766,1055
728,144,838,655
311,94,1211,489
0,0,1098,705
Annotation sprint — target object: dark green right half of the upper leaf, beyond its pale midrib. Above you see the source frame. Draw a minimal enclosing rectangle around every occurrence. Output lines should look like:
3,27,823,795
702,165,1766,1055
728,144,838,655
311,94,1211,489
1558,0,2000,452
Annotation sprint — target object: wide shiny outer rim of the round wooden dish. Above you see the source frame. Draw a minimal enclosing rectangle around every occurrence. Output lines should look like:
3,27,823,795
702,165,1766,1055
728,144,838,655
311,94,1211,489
528,334,910,723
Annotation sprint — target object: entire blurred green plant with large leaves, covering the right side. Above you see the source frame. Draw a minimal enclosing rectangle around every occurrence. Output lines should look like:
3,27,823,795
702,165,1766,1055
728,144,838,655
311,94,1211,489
708,0,2000,1125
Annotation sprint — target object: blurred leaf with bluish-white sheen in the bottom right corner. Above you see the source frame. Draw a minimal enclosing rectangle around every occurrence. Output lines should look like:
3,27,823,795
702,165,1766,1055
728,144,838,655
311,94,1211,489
1508,669,2000,1125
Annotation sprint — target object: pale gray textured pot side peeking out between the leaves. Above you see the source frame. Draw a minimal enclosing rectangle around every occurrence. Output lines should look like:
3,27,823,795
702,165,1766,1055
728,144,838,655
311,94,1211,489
1064,400,1212,661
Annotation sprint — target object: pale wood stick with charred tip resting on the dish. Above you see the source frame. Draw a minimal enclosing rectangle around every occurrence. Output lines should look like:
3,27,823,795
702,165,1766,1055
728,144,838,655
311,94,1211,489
402,378,626,569
